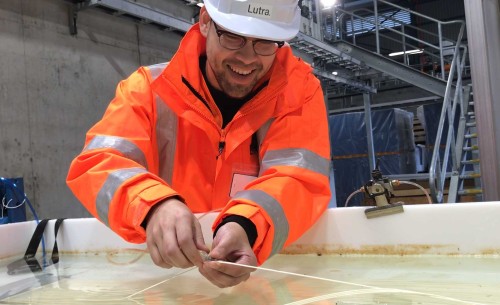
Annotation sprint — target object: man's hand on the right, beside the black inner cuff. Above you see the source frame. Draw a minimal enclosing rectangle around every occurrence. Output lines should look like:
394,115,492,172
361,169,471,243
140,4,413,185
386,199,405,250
199,222,257,288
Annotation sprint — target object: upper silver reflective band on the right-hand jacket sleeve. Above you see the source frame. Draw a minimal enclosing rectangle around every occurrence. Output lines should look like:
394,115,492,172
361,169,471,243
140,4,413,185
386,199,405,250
259,148,330,177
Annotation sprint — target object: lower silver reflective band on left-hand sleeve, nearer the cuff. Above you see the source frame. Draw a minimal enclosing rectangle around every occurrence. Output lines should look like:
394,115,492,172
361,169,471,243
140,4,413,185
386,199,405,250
96,168,146,227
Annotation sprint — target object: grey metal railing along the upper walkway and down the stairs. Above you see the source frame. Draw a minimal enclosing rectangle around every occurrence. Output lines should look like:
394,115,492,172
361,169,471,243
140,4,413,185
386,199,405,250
323,0,468,203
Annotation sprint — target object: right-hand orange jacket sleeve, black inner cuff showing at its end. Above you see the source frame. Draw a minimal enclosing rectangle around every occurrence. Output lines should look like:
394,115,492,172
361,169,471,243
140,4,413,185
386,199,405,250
215,74,331,264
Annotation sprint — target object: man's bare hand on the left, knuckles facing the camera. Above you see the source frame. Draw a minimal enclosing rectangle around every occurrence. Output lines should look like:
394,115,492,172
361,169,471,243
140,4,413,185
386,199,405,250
146,198,209,268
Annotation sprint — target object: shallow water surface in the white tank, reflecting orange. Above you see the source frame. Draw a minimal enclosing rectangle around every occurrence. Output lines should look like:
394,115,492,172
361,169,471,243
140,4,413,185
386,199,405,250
0,250,500,305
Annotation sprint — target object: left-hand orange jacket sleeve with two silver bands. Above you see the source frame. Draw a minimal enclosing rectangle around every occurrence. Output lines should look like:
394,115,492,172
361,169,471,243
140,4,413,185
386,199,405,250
66,68,179,243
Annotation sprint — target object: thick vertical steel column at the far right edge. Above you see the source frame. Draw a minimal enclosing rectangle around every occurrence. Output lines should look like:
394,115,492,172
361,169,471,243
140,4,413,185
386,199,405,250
464,0,500,201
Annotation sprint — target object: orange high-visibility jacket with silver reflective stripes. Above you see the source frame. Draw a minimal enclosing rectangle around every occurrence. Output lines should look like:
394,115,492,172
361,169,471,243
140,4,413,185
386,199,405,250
67,24,330,264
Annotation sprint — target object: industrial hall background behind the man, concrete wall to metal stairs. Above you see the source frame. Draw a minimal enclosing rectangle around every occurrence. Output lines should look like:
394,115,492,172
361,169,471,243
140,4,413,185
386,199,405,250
0,0,500,218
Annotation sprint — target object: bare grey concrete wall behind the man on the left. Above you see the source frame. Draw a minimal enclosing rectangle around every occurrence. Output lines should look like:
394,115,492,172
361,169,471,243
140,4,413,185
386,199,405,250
0,0,193,218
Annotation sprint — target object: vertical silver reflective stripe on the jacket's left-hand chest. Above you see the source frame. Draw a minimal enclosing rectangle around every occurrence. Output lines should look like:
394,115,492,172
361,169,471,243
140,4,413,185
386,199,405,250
156,96,178,185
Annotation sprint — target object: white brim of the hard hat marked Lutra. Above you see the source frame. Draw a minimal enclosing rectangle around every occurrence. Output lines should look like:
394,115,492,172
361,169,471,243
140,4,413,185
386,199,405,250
205,1,301,41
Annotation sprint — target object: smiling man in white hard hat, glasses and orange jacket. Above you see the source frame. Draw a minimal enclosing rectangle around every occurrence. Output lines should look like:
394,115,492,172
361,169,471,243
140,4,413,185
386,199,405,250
67,0,330,287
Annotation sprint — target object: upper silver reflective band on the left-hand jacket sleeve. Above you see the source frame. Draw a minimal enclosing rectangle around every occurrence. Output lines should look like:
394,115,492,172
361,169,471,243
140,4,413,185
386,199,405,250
83,135,148,168
